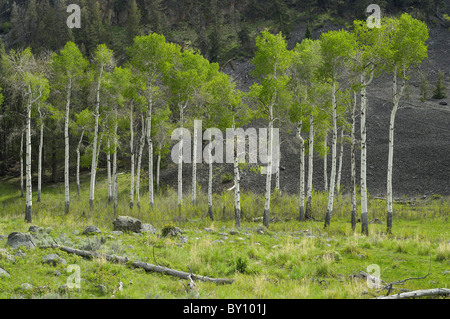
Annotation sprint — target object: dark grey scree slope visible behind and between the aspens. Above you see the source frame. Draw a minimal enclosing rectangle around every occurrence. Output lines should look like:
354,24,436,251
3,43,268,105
158,22,450,198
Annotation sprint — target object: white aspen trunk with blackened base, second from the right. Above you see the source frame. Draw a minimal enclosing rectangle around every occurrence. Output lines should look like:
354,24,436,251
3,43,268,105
360,75,369,235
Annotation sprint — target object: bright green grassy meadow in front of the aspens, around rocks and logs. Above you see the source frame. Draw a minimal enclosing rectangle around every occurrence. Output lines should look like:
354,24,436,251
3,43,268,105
0,174,450,299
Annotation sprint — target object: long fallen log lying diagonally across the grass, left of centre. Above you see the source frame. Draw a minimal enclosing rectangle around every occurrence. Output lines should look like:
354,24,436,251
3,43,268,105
51,245,234,284
